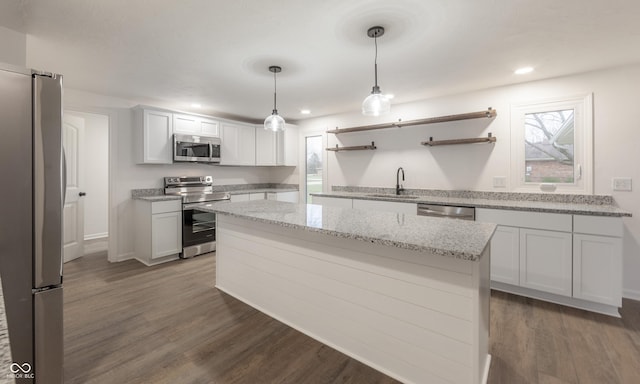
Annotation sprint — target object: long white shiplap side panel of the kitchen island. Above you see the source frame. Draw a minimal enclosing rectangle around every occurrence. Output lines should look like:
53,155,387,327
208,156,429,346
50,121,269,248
216,215,488,384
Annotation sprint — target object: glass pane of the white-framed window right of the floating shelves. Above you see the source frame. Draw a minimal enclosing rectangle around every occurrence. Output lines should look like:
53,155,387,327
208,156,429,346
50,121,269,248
524,109,575,184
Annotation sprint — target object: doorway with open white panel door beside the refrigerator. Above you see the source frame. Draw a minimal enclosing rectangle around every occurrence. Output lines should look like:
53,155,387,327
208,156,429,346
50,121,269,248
63,110,110,262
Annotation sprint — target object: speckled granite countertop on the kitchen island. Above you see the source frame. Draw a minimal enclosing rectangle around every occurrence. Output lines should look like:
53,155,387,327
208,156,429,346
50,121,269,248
203,200,496,261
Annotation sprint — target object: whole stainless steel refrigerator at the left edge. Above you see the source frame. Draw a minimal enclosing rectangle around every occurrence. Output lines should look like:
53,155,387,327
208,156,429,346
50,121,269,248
0,65,66,384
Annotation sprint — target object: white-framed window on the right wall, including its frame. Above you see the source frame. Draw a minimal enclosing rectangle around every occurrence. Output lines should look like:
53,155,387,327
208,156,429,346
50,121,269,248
511,95,593,194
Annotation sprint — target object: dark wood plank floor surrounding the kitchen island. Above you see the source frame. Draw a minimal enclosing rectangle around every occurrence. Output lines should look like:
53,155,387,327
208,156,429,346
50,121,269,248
64,254,640,384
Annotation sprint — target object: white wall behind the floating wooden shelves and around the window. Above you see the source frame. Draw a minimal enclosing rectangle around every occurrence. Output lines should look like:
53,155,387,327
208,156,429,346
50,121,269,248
299,65,640,299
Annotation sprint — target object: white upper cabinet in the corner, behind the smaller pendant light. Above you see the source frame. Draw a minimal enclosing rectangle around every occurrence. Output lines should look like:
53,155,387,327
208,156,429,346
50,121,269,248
256,124,298,167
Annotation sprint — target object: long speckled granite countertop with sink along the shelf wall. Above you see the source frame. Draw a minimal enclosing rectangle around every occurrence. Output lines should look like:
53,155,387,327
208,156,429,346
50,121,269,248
311,191,631,217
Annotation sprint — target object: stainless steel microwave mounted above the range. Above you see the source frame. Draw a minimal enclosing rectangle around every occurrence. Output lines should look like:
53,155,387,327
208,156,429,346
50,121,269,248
173,133,221,163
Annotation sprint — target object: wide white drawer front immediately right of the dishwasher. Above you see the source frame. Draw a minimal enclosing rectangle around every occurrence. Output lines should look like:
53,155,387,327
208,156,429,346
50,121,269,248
476,208,573,232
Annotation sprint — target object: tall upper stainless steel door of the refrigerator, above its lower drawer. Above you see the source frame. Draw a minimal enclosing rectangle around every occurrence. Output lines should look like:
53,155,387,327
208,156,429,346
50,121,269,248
33,75,66,289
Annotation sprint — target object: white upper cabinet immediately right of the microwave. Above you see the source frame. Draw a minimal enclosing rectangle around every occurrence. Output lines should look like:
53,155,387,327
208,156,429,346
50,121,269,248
220,121,256,166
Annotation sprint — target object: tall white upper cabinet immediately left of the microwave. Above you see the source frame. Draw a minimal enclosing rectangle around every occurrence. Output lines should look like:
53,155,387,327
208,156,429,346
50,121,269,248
134,108,173,164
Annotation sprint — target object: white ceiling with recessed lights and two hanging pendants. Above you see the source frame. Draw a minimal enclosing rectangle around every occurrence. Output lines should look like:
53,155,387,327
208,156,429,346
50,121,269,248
7,0,640,121
